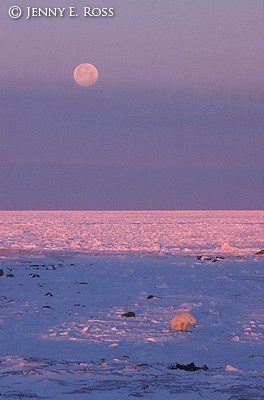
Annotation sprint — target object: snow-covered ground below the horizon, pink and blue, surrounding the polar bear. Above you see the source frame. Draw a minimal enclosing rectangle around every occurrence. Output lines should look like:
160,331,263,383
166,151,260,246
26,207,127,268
0,212,264,400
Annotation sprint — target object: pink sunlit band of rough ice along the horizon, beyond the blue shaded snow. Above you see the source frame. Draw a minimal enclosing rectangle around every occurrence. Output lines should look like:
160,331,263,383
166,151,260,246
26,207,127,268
0,211,264,256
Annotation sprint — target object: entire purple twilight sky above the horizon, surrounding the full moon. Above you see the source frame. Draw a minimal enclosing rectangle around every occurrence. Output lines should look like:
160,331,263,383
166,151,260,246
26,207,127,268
0,0,264,210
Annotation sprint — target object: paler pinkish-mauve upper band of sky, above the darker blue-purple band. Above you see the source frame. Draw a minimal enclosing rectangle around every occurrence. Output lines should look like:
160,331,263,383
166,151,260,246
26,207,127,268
0,0,264,87
